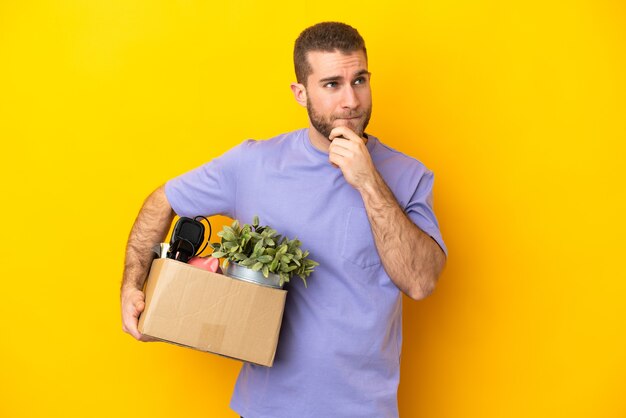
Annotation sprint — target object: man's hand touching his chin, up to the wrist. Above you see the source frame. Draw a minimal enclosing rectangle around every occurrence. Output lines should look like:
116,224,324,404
328,126,376,190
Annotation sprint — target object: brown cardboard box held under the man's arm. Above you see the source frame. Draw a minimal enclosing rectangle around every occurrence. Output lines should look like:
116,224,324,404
139,258,287,367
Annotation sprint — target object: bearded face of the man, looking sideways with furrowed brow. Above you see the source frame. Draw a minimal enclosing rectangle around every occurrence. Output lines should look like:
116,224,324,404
306,51,372,138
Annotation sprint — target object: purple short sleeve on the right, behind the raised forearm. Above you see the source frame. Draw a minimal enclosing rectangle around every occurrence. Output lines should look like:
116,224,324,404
405,170,448,256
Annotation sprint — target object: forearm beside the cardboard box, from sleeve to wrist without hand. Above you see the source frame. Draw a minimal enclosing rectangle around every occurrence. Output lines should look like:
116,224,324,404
122,187,175,291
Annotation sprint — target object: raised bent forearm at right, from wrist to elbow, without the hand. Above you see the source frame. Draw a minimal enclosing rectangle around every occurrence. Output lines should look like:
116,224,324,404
359,171,445,299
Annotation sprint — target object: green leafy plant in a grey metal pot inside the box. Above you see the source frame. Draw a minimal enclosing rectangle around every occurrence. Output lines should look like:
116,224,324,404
211,216,319,288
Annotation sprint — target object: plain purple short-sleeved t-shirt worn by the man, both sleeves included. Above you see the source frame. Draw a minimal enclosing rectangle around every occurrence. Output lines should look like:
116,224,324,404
165,129,447,418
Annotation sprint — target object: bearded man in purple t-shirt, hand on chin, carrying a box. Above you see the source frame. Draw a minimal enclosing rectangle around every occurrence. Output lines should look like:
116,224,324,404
121,22,447,418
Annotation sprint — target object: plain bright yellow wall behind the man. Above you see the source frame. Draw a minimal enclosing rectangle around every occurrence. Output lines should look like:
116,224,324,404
0,0,626,418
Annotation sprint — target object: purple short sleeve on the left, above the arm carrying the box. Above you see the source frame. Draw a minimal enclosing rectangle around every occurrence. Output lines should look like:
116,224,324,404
165,143,245,218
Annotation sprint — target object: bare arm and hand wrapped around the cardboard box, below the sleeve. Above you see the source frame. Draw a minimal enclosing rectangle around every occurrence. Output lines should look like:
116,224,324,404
120,186,175,341
